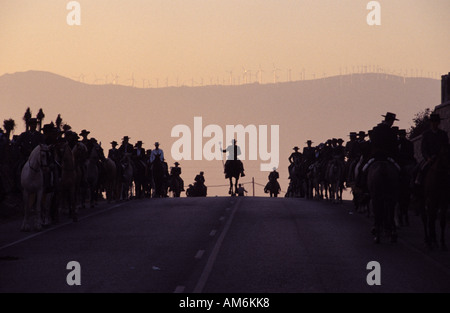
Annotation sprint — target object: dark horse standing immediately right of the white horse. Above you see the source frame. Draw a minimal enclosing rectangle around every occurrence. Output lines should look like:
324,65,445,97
55,142,78,222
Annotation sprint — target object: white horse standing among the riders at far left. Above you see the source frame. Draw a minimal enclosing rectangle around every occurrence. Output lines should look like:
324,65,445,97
20,144,50,231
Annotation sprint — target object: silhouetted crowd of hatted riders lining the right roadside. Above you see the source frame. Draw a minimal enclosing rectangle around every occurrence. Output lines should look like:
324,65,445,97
287,112,449,207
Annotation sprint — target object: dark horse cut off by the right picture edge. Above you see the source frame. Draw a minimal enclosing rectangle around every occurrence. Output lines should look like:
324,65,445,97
422,145,450,250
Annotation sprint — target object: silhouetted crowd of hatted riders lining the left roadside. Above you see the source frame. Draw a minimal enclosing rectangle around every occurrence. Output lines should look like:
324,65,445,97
0,108,207,201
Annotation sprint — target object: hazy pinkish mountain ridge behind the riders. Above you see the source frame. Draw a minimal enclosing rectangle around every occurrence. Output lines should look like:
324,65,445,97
0,71,441,195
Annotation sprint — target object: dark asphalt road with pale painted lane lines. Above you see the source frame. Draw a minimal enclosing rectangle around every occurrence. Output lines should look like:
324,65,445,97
0,197,450,293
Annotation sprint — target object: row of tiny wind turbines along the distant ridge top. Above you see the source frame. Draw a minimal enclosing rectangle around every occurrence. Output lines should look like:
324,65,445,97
72,64,440,88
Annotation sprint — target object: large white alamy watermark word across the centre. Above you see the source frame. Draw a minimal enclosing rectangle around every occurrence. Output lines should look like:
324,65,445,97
171,116,280,171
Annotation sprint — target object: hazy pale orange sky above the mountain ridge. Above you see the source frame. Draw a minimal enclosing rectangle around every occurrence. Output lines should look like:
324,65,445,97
0,0,450,87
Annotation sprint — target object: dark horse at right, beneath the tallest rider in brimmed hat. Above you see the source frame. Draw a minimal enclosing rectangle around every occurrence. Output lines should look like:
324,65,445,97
366,160,399,243
